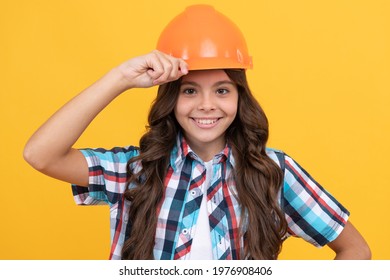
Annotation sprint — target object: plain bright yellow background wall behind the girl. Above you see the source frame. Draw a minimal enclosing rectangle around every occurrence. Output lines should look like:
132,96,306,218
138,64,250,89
0,0,390,259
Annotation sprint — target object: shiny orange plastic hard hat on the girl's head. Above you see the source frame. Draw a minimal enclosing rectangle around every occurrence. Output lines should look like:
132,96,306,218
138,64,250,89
157,5,252,70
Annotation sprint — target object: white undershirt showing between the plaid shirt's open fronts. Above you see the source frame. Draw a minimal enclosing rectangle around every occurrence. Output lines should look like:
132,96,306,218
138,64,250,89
190,160,213,260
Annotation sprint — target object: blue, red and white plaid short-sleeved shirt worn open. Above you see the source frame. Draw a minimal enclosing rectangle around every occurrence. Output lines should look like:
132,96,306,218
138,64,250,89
72,135,349,260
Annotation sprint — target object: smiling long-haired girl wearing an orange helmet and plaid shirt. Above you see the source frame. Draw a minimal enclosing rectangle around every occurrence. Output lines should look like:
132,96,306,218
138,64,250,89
24,6,370,259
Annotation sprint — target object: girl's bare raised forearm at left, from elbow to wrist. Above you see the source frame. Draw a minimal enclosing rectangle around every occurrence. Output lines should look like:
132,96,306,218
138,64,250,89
24,69,127,169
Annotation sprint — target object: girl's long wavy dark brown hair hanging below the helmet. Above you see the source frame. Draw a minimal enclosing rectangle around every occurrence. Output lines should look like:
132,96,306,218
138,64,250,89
122,69,287,259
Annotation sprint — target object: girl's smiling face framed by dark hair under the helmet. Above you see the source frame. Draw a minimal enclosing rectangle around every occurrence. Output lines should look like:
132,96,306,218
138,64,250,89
174,70,238,159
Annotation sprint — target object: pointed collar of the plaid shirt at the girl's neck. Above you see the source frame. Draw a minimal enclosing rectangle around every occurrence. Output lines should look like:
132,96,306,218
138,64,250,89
170,132,235,171
